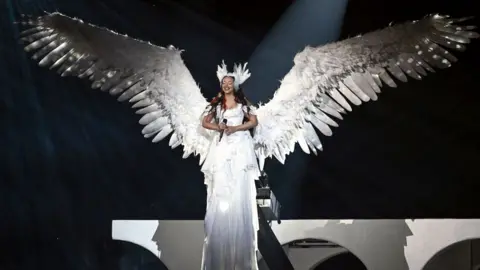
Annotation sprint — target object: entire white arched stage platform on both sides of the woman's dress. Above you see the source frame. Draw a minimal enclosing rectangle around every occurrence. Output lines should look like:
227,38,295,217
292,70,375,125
112,219,480,270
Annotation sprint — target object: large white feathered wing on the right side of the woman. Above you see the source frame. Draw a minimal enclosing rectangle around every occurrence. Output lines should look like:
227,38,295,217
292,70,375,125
254,15,479,168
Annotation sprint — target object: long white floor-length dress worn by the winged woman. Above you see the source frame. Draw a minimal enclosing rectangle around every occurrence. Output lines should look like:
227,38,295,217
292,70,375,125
201,104,260,270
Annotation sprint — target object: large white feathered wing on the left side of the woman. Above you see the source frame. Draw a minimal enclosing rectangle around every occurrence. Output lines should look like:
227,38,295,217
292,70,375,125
21,13,211,163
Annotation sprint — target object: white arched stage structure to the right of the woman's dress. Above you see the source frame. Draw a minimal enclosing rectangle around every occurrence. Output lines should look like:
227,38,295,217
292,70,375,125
272,219,480,270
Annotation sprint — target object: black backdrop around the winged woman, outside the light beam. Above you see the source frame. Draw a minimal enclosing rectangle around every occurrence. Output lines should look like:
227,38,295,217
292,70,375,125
0,0,480,269
